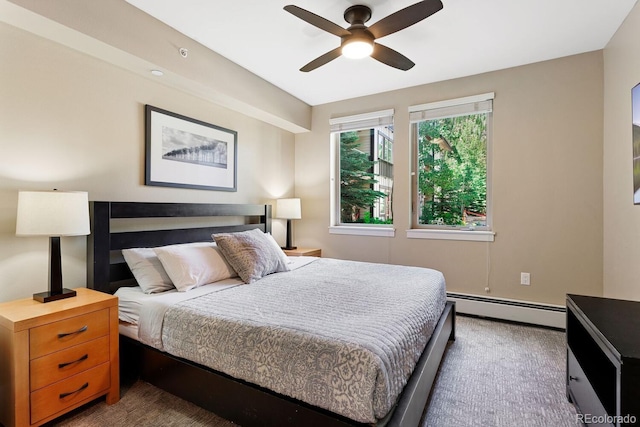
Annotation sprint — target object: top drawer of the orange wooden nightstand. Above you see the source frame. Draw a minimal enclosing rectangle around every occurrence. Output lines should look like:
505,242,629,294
29,309,109,359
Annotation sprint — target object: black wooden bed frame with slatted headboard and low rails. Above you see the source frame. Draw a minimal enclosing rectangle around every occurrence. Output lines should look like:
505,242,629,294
87,201,455,427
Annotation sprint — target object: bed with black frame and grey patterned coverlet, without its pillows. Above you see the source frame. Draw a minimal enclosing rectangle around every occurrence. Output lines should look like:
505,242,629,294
87,202,455,426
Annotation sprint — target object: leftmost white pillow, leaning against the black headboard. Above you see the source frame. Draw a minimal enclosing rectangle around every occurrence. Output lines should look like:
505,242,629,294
122,248,173,294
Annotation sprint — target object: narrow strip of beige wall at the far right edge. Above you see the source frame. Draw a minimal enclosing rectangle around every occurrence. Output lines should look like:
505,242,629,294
604,1,640,300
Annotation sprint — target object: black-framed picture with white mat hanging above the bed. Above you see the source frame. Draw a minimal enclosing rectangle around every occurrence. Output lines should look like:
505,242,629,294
145,105,238,191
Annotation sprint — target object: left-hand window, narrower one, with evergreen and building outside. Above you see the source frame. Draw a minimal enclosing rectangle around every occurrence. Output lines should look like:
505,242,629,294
330,110,393,234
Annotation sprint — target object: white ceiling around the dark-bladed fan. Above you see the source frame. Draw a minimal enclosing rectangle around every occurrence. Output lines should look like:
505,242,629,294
127,0,636,105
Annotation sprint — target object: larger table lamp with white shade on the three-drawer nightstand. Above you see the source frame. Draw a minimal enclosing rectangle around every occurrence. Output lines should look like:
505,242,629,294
16,190,90,302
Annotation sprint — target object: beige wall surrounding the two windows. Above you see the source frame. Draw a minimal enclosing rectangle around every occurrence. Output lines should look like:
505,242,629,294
296,51,603,305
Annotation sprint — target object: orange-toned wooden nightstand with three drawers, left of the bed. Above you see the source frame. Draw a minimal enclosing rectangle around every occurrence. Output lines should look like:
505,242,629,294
0,288,120,427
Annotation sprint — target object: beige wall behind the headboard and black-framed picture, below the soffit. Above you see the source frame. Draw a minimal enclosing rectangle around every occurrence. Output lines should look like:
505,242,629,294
0,23,294,301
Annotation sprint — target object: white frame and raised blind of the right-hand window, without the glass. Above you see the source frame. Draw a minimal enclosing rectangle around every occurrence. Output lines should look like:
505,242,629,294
407,92,495,242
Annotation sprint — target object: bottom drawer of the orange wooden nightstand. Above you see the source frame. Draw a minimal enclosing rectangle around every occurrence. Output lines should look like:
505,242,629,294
31,363,110,424
